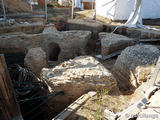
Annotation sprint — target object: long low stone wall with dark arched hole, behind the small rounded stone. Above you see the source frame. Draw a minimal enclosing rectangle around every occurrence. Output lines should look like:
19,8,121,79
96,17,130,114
0,30,91,61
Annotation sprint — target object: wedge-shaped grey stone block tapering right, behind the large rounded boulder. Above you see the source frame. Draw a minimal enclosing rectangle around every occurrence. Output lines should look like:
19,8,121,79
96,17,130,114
99,32,134,56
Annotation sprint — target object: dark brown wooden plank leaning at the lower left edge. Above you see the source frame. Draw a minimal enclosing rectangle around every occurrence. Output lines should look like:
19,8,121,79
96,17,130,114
0,54,23,120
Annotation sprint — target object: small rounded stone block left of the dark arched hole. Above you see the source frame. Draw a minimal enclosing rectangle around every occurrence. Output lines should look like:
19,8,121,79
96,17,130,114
24,48,47,76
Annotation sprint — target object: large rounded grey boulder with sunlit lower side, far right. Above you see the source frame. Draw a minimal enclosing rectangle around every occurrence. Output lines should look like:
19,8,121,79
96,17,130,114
112,45,160,90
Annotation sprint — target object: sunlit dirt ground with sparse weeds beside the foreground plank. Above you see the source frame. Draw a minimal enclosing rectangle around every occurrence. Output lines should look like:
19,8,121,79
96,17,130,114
68,88,132,120
